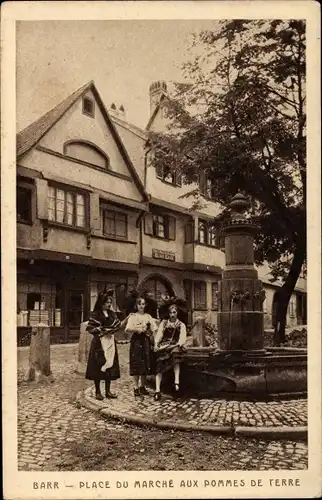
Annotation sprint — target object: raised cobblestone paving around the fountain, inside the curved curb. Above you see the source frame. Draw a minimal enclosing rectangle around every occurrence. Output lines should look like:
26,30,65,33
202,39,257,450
85,346,307,427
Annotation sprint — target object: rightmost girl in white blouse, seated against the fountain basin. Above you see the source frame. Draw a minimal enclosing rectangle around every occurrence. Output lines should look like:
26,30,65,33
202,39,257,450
154,304,187,401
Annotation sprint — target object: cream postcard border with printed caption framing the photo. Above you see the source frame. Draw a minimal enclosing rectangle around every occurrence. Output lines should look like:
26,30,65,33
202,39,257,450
1,0,322,500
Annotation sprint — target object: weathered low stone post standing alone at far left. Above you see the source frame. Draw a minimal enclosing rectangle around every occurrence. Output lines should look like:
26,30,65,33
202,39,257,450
25,323,53,382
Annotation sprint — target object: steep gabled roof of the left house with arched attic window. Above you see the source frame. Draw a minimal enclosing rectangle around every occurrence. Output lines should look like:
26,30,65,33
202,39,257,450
16,81,149,201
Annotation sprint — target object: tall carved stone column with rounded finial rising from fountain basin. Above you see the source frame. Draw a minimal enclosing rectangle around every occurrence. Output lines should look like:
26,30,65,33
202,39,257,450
218,193,265,354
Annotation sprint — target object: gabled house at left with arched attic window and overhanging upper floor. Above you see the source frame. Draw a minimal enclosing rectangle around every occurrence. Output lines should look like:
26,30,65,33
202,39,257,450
17,82,148,341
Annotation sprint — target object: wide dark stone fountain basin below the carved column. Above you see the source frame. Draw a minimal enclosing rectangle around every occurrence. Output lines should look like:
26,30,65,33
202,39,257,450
164,347,307,400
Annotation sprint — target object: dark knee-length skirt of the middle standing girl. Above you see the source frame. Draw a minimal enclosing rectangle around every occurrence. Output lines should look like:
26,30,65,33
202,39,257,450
130,333,155,376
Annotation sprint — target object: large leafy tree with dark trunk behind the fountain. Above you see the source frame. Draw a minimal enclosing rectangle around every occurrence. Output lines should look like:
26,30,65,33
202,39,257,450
150,20,306,344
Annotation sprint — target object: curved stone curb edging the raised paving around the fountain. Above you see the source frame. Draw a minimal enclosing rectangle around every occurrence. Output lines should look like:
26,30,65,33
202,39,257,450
76,391,308,441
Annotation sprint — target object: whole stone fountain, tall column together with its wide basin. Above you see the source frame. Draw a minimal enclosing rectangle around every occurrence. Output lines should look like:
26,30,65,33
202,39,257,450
172,193,307,399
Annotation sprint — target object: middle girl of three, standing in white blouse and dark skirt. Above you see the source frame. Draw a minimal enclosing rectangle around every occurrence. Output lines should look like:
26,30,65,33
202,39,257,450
125,297,158,396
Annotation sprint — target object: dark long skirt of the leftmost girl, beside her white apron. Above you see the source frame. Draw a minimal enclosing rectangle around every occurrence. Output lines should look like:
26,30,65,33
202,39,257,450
85,335,120,380
